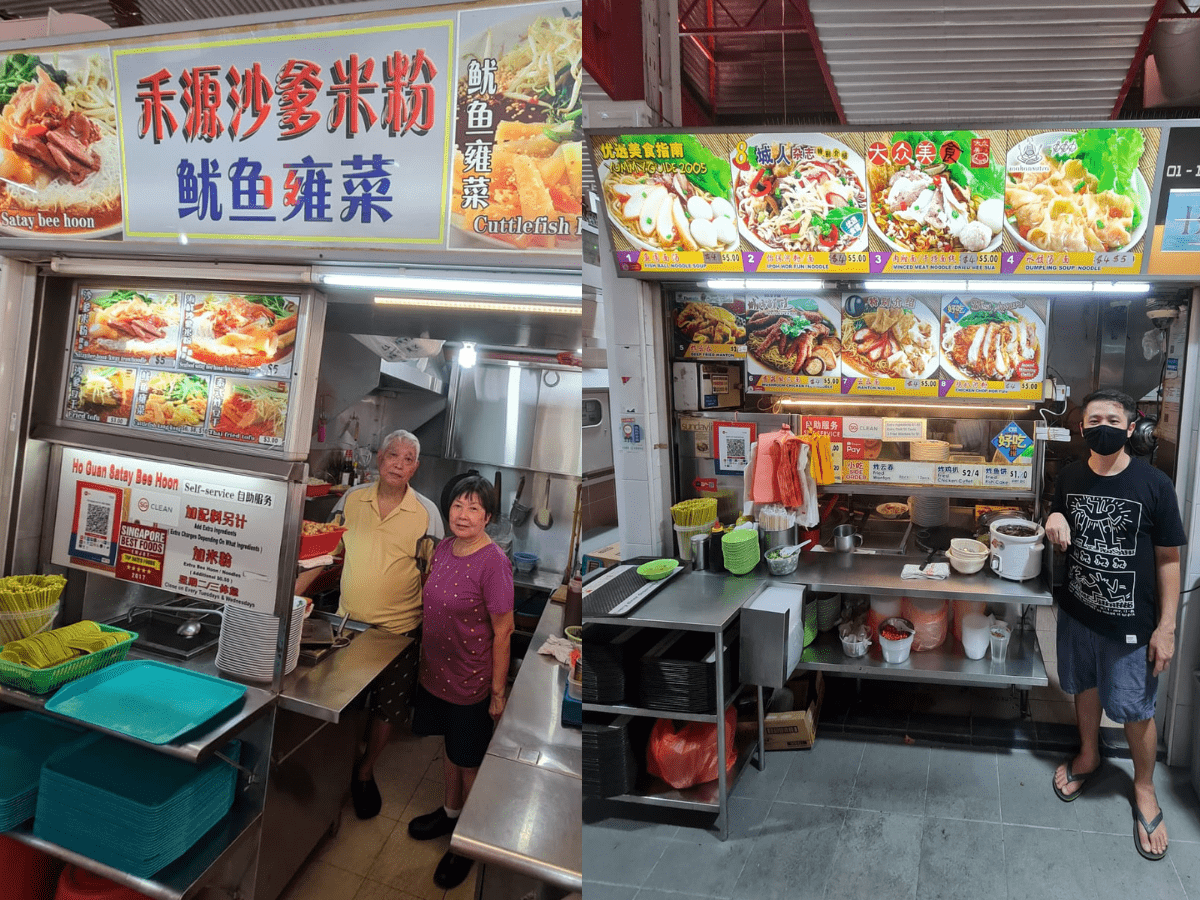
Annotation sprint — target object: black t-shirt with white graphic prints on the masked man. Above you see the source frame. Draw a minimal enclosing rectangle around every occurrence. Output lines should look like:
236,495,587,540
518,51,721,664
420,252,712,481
1050,457,1187,644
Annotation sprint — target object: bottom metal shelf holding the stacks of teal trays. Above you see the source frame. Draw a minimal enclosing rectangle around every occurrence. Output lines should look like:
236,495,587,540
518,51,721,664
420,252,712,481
6,804,263,900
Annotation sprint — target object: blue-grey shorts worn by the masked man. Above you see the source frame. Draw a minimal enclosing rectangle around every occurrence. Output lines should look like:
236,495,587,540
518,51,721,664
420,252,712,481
1056,607,1158,725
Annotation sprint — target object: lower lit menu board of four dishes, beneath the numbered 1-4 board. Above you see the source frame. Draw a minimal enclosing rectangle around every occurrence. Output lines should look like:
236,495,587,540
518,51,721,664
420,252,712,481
672,292,1050,400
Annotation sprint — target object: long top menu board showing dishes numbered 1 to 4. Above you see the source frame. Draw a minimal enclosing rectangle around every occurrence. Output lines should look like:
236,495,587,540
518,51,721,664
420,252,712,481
589,125,1166,277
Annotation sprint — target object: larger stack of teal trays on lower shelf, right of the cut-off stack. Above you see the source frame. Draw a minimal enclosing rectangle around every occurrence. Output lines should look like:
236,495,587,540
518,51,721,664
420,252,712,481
34,734,240,877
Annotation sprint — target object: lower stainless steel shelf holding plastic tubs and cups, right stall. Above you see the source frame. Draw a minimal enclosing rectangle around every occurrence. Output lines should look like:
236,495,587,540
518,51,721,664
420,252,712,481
797,630,1049,688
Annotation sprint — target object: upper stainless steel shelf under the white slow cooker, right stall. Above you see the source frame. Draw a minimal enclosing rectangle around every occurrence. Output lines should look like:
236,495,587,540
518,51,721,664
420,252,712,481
787,552,1054,606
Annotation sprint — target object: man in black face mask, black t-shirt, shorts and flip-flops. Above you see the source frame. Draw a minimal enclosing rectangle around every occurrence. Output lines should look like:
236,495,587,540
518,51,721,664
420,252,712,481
1046,390,1187,859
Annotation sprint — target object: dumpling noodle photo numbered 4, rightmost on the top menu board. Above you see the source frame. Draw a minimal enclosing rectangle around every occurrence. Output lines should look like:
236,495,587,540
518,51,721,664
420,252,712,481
1004,128,1150,253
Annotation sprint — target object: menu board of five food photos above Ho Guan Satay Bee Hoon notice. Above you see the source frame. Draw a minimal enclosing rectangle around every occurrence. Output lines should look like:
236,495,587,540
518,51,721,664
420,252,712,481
62,286,301,452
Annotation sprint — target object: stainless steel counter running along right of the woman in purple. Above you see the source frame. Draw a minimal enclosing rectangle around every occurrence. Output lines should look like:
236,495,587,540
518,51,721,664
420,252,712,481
450,602,583,890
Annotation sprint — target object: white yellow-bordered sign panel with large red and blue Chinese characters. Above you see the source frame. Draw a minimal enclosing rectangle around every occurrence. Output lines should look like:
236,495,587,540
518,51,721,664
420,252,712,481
113,19,454,246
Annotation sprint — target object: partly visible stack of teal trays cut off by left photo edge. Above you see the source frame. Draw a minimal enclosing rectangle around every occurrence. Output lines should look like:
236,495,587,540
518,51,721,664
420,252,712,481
0,713,84,832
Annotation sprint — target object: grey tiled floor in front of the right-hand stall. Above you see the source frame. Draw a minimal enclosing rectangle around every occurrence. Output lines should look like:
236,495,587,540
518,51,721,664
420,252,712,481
583,734,1200,900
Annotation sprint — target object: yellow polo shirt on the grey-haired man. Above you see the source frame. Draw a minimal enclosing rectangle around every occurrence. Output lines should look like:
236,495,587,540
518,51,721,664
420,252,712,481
338,481,443,635
